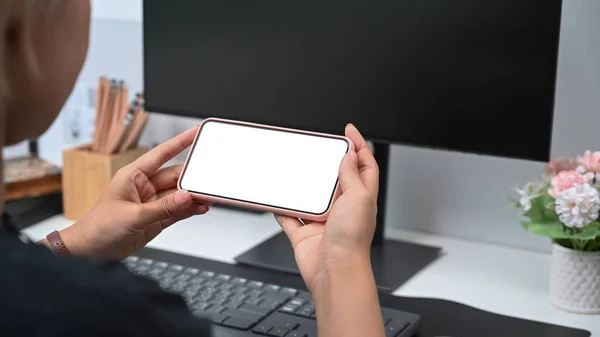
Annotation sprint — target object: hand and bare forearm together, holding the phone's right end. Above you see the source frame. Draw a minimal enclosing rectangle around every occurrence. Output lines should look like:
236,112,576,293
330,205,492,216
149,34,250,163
276,125,385,337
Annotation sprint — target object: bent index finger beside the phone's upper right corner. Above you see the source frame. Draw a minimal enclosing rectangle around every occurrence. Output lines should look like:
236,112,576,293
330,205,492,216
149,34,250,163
346,124,379,196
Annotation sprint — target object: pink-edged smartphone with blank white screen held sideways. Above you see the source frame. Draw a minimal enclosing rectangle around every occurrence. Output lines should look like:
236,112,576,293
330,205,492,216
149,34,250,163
178,118,353,221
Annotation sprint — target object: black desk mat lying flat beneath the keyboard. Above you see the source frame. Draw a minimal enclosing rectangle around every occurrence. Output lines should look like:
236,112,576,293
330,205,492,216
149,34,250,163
137,248,600,337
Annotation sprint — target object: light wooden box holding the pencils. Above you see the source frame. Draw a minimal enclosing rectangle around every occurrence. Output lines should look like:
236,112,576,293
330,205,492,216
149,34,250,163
62,145,148,221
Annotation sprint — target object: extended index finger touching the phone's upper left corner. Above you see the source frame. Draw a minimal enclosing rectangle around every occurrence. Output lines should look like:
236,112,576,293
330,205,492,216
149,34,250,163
133,126,198,176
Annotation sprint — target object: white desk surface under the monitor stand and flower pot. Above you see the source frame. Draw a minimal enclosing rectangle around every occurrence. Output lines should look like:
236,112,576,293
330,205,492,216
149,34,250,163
25,208,600,337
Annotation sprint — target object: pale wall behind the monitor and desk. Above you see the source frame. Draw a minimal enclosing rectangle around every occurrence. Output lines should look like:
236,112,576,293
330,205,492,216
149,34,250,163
9,0,600,251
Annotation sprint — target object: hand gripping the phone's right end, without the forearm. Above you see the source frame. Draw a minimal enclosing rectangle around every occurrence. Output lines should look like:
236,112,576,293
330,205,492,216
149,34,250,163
275,125,379,291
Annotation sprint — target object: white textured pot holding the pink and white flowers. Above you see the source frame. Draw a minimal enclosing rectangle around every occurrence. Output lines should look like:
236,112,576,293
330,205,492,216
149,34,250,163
550,243,600,314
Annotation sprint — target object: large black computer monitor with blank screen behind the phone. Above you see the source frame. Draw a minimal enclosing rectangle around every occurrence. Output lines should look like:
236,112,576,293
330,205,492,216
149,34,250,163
143,0,562,289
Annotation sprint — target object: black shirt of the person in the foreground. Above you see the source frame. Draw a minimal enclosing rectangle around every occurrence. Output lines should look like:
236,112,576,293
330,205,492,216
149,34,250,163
0,215,211,337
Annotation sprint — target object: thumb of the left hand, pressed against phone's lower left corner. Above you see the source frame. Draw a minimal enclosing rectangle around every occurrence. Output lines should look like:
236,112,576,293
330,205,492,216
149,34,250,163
138,190,192,224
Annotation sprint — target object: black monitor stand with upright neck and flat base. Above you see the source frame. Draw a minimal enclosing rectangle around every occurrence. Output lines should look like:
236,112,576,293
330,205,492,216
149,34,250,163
235,143,441,292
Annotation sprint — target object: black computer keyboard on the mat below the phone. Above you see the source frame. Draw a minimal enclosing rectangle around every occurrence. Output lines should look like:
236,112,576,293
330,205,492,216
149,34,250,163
123,256,419,337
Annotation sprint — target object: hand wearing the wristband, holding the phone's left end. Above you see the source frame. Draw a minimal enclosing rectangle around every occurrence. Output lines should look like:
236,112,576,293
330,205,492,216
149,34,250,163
60,127,208,258
